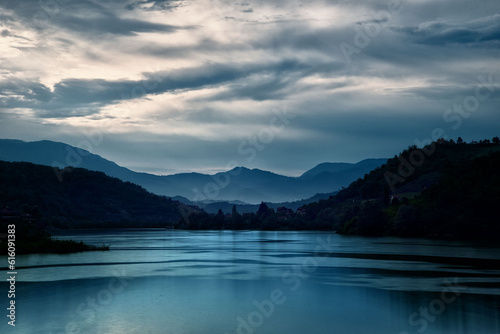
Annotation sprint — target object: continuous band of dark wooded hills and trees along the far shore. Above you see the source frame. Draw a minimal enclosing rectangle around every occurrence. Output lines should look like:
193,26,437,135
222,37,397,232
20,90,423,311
0,137,500,238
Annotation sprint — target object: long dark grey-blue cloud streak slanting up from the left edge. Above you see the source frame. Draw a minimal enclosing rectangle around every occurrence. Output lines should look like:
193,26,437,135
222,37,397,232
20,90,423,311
0,60,324,117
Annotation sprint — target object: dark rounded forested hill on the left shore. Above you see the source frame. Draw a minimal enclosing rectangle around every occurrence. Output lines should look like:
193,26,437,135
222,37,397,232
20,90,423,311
0,161,189,227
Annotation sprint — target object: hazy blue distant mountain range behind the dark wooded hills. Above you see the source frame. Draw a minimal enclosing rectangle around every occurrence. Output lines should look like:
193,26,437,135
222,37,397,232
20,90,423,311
0,139,387,204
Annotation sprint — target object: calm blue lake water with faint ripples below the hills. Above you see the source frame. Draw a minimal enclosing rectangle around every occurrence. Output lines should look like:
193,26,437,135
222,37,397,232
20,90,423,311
0,230,500,334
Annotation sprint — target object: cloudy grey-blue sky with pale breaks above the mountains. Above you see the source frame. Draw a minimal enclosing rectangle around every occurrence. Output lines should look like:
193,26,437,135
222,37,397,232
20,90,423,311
0,0,500,175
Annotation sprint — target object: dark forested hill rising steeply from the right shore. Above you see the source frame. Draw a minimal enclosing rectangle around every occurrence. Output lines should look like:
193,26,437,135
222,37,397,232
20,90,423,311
301,137,500,238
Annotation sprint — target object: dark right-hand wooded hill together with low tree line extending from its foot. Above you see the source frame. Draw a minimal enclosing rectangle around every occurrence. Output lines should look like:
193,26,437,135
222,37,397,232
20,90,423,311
177,137,500,238
